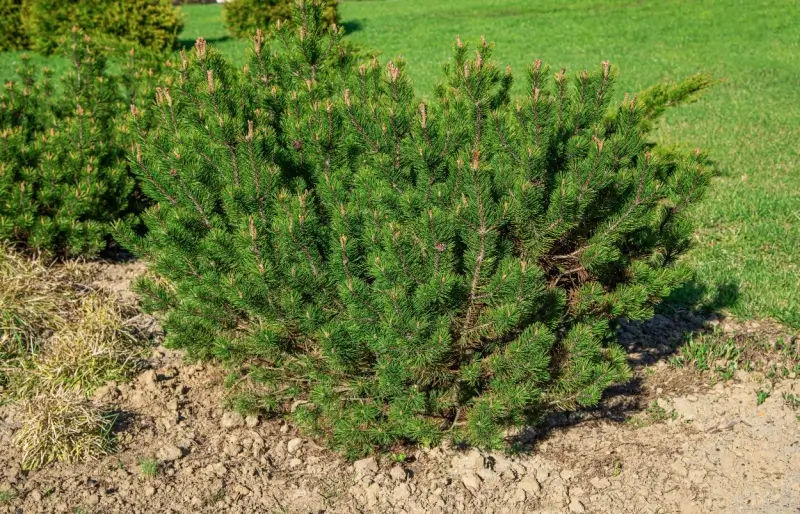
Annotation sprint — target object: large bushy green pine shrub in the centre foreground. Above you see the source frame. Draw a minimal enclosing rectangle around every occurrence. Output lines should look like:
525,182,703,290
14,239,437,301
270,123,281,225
119,2,711,457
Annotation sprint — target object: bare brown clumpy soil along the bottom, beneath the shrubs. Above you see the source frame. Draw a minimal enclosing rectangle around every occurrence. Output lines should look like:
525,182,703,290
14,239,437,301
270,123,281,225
0,263,800,514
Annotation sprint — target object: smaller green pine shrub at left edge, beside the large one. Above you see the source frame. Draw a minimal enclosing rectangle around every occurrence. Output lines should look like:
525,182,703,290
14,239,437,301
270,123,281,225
0,31,148,256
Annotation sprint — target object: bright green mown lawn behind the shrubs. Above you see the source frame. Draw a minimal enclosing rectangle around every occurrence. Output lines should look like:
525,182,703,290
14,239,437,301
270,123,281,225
0,0,800,327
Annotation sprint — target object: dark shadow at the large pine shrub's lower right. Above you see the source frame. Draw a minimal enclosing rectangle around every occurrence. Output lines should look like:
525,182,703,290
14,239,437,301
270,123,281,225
510,281,739,453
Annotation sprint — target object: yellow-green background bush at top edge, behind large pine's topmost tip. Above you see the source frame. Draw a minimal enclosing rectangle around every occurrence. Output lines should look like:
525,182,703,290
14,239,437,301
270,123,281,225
223,0,339,38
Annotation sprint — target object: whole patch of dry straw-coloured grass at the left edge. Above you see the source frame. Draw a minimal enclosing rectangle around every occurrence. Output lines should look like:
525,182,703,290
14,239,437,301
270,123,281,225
0,245,147,469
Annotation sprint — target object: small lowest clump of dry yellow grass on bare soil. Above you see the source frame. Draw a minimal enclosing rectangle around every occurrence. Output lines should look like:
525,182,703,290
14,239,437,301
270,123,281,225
14,390,114,470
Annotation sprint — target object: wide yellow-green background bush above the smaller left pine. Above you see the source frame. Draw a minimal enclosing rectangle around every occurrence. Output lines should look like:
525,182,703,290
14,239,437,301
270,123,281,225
23,0,183,54
